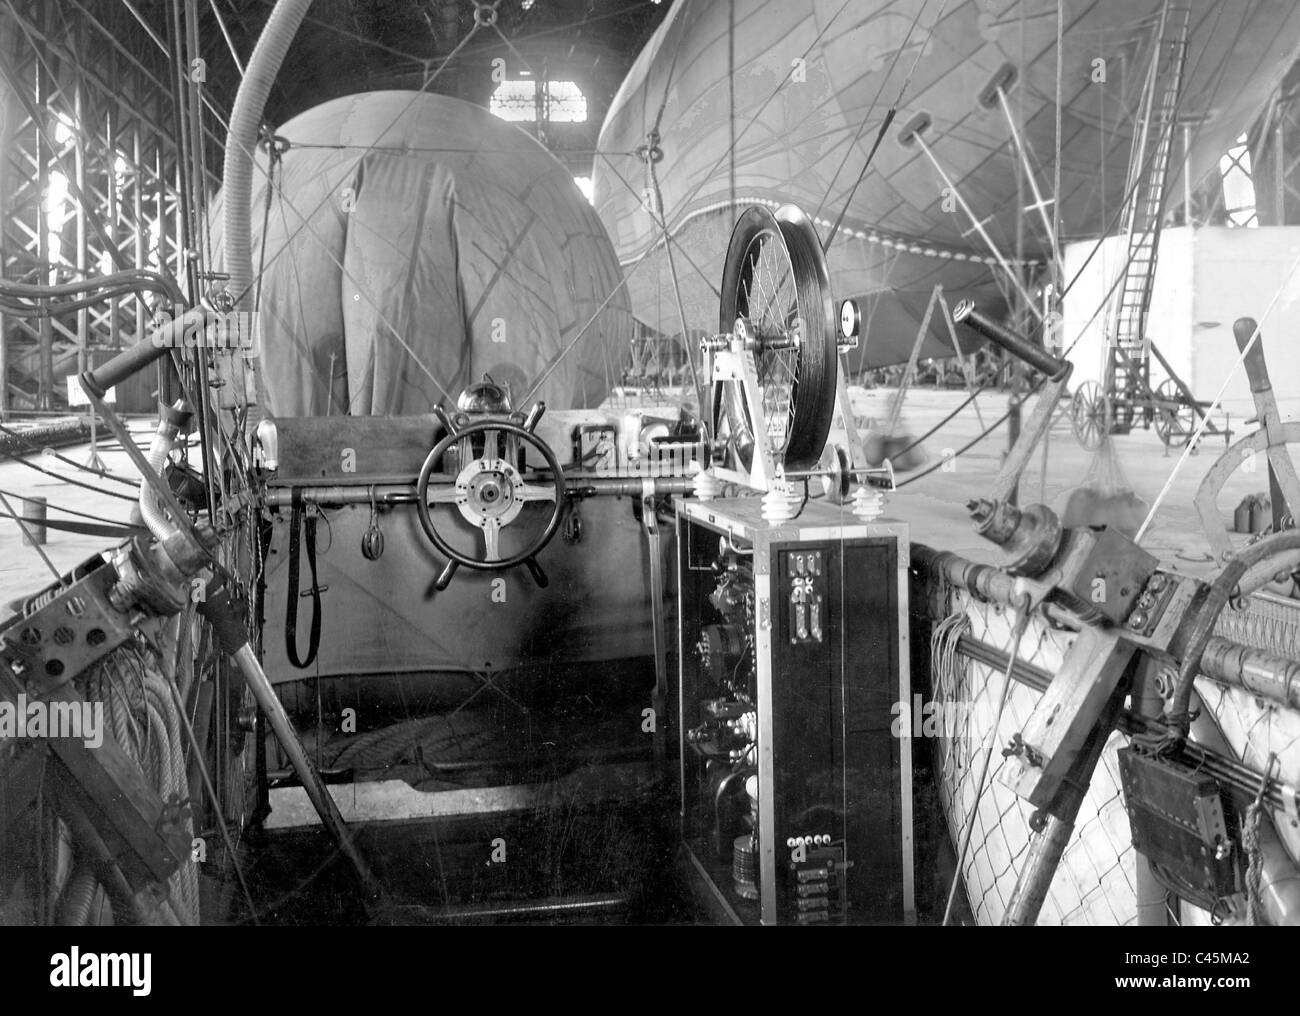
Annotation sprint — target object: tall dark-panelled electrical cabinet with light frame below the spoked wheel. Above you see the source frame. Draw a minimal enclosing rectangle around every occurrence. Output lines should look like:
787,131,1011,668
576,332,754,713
677,498,915,925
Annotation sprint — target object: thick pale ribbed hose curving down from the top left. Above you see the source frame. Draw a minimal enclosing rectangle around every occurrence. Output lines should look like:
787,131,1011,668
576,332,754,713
222,0,312,308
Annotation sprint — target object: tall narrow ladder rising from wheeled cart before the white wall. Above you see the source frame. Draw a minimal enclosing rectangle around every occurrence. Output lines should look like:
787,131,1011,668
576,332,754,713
1104,0,1191,434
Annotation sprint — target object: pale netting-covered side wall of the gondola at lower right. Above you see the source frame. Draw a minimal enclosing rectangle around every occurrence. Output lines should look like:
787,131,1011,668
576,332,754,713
932,590,1300,925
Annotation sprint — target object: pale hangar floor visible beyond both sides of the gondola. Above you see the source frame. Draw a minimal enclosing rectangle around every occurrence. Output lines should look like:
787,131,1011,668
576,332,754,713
0,388,1268,603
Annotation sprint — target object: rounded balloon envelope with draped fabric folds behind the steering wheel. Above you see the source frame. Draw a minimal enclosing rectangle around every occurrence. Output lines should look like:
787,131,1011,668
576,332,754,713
212,91,632,416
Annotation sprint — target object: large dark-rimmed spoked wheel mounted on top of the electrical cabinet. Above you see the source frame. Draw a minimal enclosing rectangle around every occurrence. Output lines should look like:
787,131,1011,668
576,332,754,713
714,205,839,478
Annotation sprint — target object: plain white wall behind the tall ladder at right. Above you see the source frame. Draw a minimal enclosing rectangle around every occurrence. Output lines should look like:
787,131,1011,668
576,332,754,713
1063,226,1300,426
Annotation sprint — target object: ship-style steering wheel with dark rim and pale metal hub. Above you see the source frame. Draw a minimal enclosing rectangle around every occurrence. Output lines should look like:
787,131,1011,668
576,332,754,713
416,420,564,590
